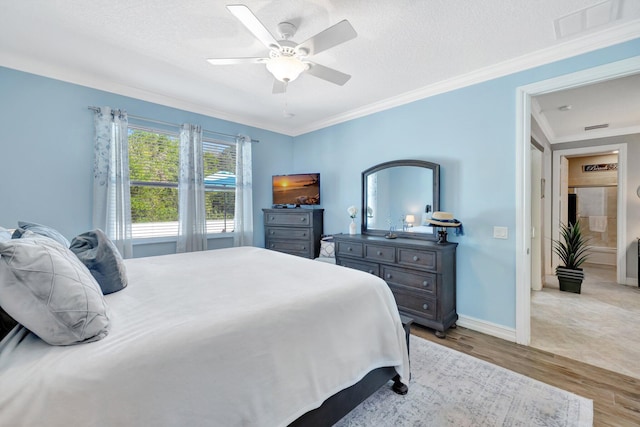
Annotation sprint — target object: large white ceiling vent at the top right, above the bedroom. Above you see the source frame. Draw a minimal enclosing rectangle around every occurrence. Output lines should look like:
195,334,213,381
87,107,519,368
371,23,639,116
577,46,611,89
553,0,622,39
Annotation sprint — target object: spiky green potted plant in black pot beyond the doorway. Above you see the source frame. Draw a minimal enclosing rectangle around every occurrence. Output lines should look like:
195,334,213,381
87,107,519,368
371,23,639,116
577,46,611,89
553,221,589,294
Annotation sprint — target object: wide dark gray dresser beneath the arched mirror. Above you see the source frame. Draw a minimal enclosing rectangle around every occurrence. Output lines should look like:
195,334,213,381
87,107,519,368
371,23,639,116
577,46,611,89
333,234,458,338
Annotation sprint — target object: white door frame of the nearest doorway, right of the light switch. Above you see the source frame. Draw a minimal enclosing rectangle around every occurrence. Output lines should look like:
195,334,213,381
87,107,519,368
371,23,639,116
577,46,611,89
515,56,640,345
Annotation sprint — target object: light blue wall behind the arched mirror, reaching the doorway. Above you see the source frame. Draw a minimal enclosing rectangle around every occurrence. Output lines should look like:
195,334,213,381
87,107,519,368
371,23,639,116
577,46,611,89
294,39,640,328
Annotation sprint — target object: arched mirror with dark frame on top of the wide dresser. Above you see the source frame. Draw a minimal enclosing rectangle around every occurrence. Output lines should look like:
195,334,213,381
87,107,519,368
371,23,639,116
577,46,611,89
361,160,440,240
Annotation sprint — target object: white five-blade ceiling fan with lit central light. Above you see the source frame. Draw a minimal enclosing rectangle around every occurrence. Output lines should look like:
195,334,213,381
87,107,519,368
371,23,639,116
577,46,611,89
207,4,357,93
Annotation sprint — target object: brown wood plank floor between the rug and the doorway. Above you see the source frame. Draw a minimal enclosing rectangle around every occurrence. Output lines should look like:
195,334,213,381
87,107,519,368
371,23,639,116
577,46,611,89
411,324,640,427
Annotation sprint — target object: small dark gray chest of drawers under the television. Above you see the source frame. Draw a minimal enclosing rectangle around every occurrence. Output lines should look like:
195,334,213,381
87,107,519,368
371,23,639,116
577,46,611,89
262,208,324,259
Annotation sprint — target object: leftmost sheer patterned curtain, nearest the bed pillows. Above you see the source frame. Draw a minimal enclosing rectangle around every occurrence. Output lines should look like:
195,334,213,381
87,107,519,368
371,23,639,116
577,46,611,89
93,107,133,258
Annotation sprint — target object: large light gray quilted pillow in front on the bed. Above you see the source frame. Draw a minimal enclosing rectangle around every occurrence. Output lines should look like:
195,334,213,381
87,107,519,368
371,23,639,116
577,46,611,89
0,236,110,345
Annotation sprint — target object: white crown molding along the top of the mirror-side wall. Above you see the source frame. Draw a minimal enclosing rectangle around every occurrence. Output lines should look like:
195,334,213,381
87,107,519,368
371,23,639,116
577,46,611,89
292,19,640,136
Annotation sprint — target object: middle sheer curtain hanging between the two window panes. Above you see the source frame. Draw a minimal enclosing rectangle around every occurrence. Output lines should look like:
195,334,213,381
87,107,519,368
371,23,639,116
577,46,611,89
176,124,207,252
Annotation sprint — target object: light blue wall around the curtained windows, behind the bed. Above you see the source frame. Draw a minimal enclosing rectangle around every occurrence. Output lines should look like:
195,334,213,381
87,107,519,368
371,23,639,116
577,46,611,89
0,67,293,256
